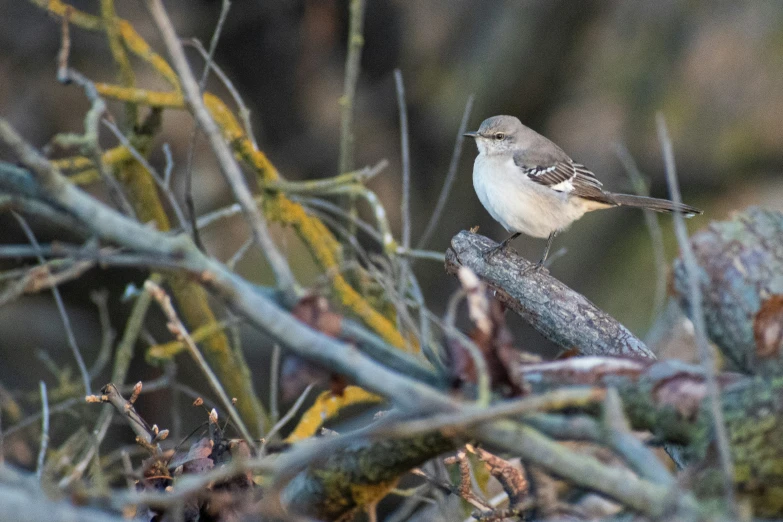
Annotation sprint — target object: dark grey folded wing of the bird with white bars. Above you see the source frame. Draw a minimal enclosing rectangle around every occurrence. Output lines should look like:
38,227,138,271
514,152,614,204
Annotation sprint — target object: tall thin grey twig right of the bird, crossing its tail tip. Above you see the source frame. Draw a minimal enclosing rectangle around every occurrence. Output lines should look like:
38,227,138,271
656,113,737,514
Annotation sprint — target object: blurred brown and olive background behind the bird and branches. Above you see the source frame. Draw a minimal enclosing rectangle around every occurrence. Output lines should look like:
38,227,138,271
0,0,783,446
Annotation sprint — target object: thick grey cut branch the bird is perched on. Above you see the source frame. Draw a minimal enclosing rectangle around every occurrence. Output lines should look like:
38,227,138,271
446,230,655,359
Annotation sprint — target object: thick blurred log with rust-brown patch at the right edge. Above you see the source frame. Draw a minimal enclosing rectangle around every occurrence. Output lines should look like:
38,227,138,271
673,208,783,375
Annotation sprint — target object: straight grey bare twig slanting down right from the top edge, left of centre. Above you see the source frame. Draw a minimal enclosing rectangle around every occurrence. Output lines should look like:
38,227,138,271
147,0,298,298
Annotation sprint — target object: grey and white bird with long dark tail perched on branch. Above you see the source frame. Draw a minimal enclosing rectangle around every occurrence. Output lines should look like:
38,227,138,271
465,116,702,269
